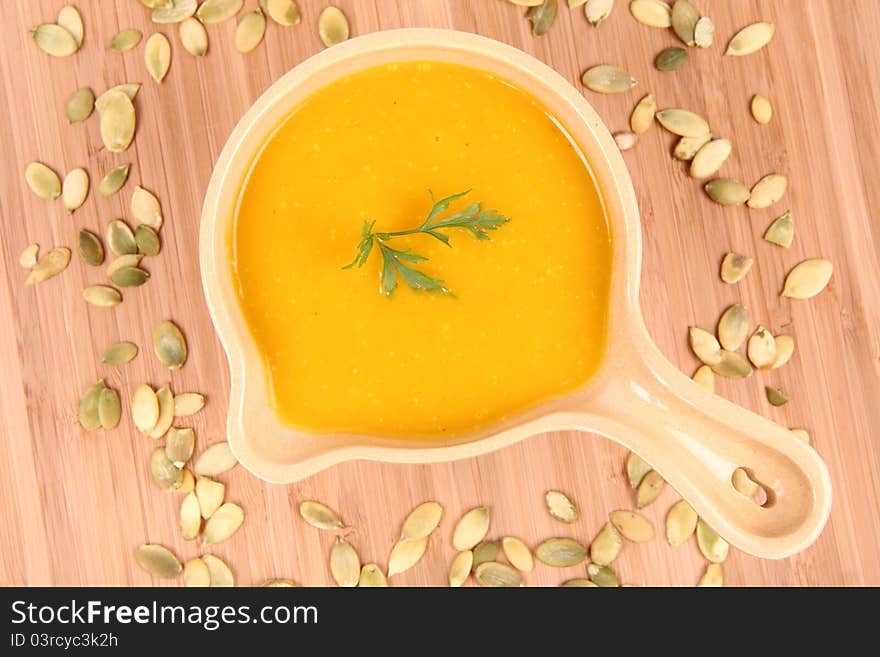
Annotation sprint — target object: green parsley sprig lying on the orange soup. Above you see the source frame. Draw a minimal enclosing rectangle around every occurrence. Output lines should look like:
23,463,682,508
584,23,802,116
343,189,509,297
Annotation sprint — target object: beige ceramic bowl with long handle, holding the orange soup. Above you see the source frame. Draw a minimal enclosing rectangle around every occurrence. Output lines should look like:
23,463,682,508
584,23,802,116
200,29,831,557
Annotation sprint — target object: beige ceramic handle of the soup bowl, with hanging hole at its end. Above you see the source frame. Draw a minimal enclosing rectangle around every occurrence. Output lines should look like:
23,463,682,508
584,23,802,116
581,336,831,559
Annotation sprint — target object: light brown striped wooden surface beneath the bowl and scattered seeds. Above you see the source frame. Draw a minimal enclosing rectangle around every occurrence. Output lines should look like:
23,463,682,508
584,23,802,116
0,0,880,585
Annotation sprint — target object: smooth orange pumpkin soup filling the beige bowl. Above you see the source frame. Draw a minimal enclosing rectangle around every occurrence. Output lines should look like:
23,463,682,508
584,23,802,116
231,62,612,438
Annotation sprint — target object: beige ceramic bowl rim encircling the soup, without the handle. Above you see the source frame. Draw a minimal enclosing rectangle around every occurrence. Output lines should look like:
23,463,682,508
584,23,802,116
199,28,644,483
